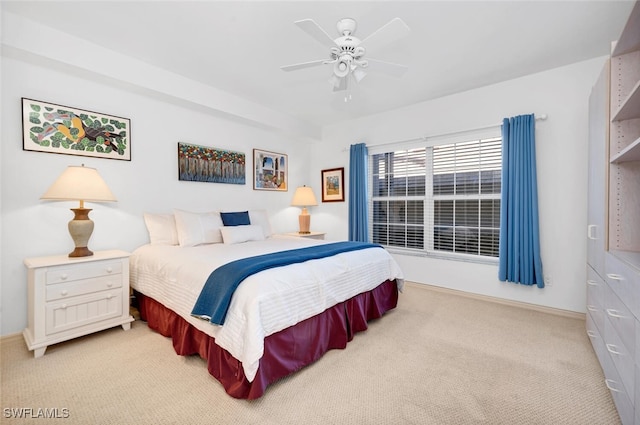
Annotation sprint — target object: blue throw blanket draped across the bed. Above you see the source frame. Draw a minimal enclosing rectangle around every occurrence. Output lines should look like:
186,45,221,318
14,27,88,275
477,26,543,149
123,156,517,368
191,242,382,325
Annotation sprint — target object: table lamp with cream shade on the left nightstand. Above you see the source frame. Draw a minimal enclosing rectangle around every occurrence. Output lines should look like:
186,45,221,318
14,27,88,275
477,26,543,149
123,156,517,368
40,164,116,257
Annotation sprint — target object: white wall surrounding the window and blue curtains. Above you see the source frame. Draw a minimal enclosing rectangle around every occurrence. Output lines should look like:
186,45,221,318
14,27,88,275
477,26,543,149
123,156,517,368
312,58,606,312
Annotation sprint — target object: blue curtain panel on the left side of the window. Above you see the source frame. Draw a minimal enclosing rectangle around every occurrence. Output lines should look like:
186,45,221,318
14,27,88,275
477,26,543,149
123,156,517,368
349,143,369,242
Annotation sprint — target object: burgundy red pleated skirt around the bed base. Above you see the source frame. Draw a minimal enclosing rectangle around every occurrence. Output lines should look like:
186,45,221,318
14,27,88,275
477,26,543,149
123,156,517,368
136,281,398,399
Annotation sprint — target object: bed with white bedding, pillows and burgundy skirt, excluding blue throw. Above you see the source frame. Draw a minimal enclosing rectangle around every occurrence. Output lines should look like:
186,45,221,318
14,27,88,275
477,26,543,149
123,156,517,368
130,210,403,399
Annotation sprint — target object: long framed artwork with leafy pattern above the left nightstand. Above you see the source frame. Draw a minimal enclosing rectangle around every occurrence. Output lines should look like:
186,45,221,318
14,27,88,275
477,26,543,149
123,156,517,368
22,97,131,161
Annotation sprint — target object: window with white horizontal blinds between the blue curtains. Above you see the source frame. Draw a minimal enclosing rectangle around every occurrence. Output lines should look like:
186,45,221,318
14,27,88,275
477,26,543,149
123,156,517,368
369,137,502,258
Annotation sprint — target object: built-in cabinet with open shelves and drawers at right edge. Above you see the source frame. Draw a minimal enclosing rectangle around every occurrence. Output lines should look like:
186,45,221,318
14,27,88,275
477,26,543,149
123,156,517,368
586,2,640,425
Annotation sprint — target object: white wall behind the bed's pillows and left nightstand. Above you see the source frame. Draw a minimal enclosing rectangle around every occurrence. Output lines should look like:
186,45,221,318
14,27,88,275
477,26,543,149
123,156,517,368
0,46,319,335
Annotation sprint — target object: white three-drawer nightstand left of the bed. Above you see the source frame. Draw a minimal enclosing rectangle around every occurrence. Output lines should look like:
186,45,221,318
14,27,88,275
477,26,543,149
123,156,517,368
22,250,134,357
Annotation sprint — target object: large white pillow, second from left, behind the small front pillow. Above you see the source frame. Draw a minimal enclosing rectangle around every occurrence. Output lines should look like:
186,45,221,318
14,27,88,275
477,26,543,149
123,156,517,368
173,210,222,247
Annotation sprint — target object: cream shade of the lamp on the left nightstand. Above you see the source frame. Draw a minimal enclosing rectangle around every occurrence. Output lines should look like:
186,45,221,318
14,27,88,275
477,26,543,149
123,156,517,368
40,165,116,202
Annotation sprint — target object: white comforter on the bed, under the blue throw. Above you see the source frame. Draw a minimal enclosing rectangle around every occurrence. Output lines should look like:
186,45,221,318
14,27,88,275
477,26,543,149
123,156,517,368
130,237,403,381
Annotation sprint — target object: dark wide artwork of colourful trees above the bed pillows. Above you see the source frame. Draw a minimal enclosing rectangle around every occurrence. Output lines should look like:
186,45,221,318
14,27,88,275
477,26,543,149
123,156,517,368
178,142,246,184
